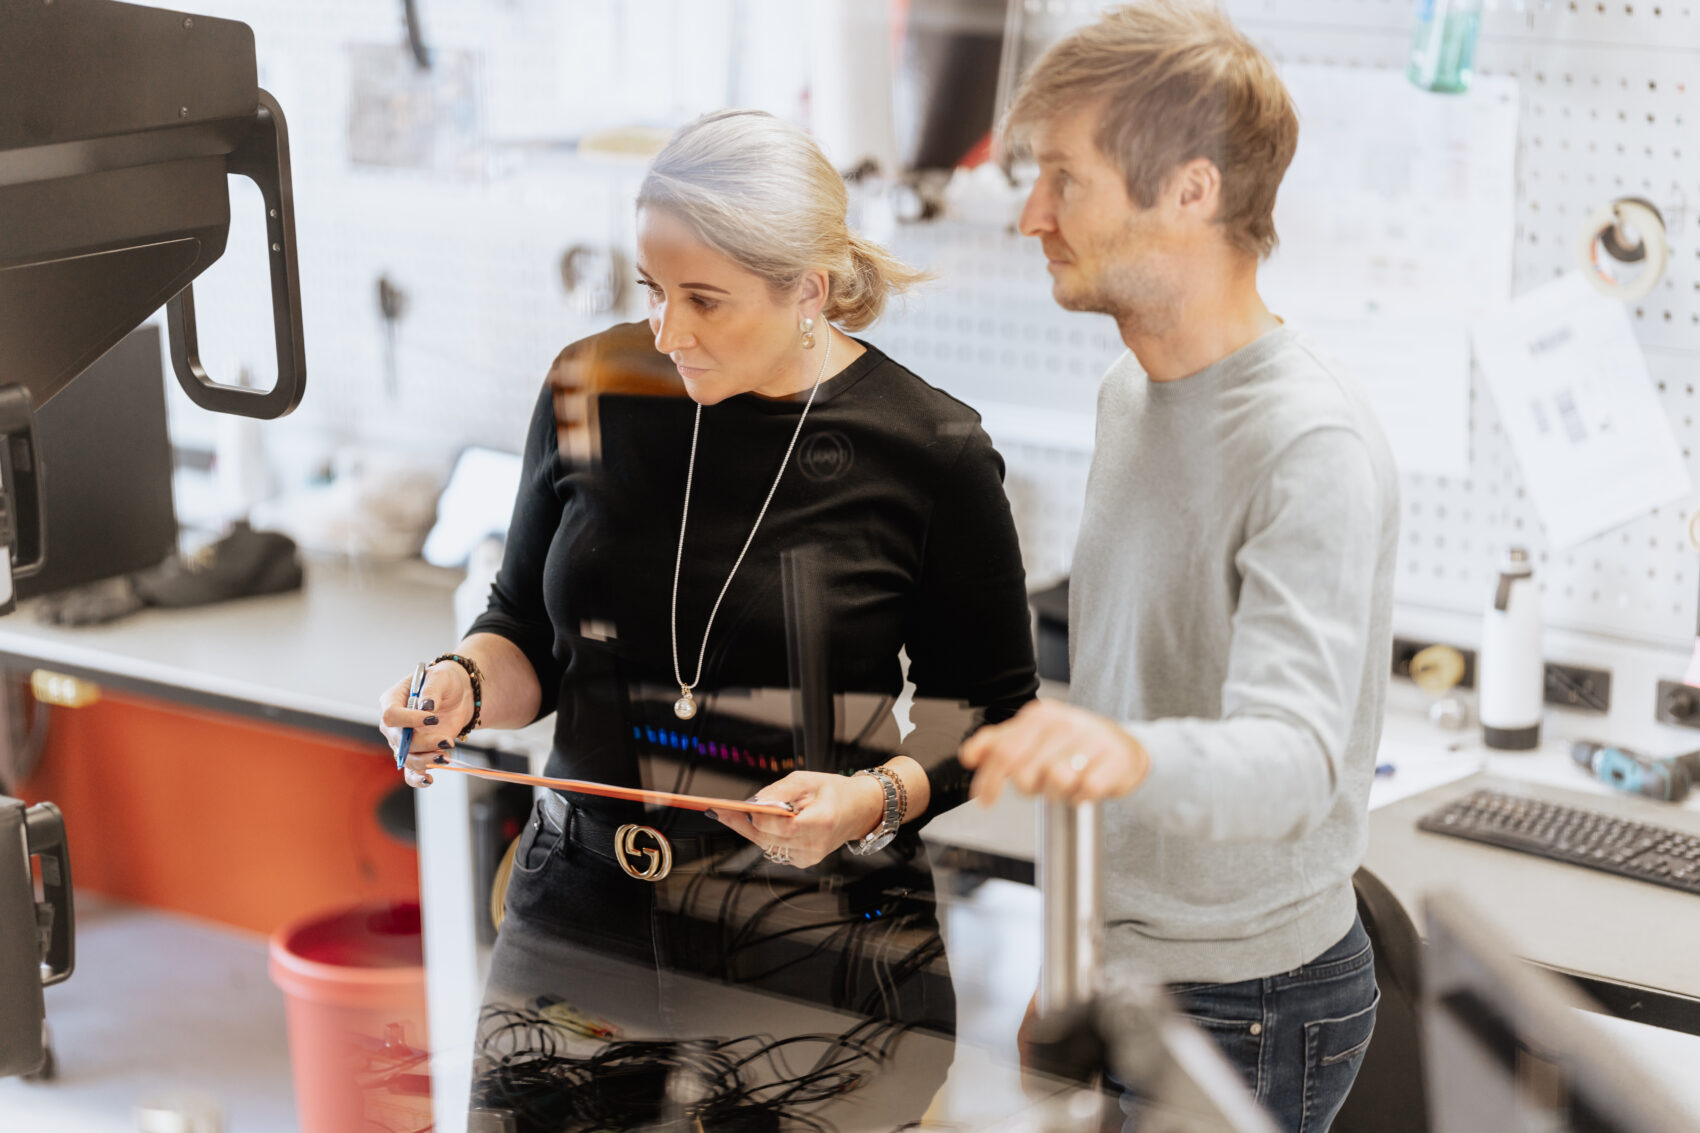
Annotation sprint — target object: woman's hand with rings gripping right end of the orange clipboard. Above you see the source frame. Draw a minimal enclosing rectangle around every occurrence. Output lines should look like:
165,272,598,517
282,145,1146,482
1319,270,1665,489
709,771,886,869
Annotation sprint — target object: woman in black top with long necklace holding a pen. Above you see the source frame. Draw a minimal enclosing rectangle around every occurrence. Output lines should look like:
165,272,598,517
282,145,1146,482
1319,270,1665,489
383,111,1037,1121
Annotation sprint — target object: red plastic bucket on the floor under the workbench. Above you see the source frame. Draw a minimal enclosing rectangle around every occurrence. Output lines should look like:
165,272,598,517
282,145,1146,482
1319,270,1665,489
270,902,430,1133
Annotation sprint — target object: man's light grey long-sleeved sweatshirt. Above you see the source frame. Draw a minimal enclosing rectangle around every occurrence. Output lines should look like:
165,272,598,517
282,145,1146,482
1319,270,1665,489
1069,327,1399,983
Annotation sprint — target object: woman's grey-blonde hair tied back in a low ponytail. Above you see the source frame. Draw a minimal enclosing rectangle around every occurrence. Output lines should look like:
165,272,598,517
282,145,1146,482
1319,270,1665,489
638,111,928,330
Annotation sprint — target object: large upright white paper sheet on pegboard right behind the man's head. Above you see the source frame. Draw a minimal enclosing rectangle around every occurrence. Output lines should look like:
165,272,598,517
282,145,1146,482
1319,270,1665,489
1258,65,1518,476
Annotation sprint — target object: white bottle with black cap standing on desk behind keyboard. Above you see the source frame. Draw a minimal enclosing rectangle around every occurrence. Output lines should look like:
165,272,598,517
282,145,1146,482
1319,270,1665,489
1477,546,1547,752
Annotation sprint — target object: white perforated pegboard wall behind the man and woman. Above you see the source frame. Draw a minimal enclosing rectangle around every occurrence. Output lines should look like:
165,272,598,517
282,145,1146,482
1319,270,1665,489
132,0,1700,645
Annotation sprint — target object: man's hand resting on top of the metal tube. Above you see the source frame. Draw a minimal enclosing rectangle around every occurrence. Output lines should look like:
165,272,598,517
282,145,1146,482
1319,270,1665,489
962,701,1151,806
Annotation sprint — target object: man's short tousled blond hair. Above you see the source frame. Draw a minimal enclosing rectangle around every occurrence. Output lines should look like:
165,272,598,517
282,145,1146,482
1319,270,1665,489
1005,0,1299,259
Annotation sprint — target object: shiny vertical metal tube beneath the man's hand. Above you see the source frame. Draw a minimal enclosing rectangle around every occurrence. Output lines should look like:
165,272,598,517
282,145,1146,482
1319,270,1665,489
1039,801,1103,1016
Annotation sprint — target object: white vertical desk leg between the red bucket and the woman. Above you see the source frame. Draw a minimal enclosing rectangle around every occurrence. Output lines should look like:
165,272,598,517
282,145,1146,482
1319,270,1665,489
415,774,481,1133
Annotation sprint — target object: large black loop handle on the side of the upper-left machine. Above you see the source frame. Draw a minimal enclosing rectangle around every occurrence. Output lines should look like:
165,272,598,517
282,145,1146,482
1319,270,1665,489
165,90,308,418
